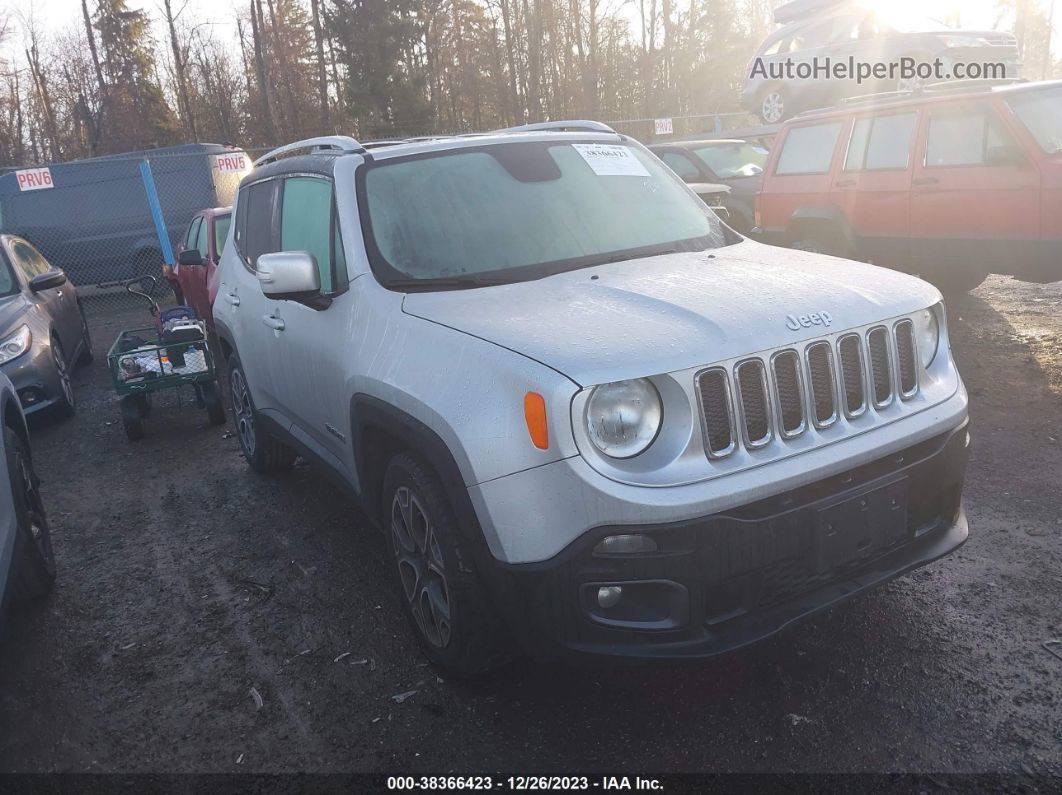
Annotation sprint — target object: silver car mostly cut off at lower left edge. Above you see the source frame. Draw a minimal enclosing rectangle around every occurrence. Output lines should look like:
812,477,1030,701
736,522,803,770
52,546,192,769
0,373,55,622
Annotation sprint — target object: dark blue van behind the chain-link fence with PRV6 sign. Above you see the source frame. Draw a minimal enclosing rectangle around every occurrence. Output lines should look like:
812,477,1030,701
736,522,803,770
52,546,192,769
0,143,251,286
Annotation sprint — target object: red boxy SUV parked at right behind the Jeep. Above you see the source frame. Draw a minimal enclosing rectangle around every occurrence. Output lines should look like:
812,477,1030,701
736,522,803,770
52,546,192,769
756,82,1062,293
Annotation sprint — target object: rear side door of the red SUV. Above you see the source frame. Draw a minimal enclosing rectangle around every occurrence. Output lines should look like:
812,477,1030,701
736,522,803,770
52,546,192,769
833,108,919,267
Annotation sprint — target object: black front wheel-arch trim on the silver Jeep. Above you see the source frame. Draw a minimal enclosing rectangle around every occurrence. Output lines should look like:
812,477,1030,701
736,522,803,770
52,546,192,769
350,393,486,547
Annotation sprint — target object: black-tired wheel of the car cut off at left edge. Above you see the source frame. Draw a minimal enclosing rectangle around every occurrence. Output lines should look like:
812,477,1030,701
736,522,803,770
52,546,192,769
3,428,55,602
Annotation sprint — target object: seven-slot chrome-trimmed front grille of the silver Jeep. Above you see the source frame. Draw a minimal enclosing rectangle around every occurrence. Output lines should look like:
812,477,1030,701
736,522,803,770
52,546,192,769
697,319,919,459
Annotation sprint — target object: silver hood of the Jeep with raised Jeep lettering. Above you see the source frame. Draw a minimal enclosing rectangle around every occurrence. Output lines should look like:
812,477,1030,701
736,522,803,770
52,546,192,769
402,241,940,386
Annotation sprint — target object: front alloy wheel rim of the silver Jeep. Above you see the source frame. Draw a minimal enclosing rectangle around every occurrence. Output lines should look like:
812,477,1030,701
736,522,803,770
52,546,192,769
391,486,452,649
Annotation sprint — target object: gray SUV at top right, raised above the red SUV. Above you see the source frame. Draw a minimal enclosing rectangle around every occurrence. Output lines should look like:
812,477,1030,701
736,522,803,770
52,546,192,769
741,1,1020,124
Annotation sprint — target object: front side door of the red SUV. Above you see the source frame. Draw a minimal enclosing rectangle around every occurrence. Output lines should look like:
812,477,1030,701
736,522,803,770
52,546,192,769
911,101,1040,273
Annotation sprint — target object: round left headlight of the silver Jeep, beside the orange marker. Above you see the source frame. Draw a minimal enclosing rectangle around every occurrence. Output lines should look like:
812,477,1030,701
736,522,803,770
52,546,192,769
586,378,664,459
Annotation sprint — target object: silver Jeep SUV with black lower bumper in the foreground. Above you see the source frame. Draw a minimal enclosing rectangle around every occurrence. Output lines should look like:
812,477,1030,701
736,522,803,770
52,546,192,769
213,122,969,675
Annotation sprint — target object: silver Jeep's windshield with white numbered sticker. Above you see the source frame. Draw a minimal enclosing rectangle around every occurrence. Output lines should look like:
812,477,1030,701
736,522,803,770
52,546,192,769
359,141,726,289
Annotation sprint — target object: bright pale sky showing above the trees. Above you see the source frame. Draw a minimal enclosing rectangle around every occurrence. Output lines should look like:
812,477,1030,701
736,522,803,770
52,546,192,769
2,0,1062,68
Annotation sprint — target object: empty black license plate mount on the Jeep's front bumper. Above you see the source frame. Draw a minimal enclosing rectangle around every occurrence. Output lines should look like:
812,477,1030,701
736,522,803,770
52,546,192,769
816,478,908,572
